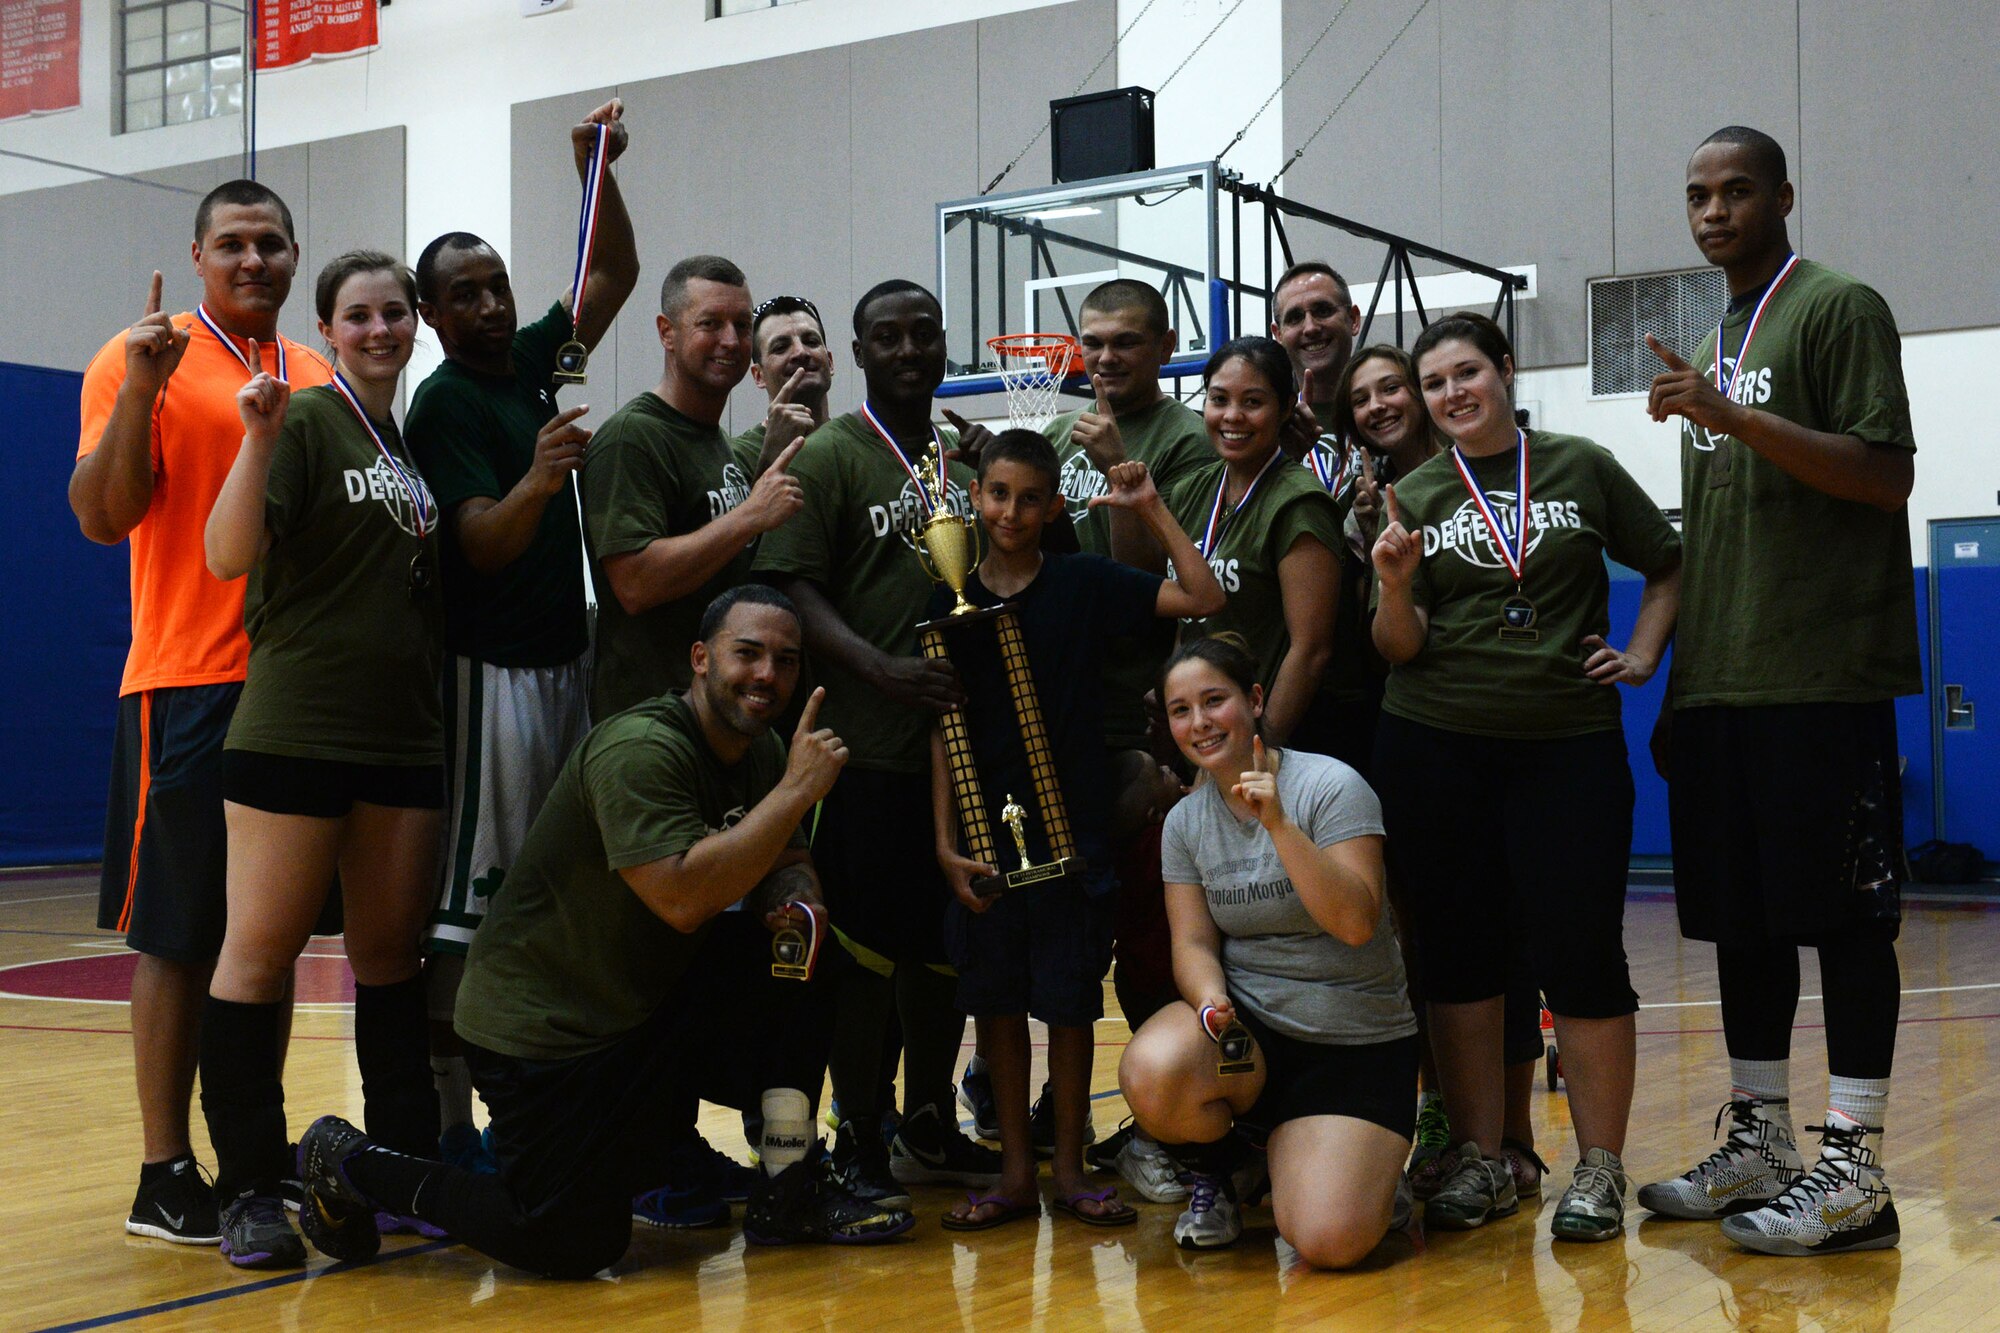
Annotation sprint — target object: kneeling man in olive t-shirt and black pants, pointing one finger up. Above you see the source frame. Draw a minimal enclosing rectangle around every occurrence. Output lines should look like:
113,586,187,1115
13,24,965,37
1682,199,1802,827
300,586,914,1277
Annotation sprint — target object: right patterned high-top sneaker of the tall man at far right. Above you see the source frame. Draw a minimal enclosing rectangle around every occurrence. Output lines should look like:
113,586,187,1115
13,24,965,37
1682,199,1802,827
1722,1113,1902,1257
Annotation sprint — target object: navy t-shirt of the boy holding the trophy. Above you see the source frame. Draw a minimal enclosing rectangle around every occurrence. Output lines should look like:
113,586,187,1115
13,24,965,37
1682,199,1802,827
930,552,1162,872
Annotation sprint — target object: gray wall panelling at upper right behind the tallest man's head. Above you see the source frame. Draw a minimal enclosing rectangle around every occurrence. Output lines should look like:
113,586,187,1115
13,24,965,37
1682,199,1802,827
1284,0,2000,366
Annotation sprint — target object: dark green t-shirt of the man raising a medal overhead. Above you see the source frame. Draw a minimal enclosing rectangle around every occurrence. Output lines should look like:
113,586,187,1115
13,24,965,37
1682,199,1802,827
404,302,590,667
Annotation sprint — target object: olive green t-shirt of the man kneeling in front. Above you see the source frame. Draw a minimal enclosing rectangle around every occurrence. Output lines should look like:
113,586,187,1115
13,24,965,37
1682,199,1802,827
456,695,806,1061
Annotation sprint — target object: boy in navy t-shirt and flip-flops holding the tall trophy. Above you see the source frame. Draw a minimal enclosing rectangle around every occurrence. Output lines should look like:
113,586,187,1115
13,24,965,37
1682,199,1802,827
914,430,1224,1231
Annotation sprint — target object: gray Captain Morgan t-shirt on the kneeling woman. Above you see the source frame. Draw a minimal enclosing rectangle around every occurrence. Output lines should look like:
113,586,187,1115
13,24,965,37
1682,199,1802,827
1160,751,1416,1047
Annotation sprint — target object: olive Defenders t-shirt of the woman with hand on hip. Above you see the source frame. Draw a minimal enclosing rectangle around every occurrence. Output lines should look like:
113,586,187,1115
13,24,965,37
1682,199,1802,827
1378,430,1680,739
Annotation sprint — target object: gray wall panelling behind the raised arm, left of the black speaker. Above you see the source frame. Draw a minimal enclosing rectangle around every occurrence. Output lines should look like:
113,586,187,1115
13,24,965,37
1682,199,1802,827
508,0,1118,430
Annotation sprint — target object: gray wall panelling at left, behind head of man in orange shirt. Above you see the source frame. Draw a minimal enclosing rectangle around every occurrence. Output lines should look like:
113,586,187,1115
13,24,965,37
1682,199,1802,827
0,126,406,370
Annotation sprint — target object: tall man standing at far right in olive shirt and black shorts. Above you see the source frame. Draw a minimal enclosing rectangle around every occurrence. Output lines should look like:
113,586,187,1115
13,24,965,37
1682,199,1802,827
1638,126,1922,1255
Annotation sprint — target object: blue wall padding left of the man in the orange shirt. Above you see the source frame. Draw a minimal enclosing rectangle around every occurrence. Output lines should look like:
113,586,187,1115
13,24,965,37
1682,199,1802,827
0,362,132,865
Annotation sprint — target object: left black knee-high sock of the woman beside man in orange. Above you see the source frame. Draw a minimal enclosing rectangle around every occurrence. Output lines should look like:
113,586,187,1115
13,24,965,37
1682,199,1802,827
200,995,292,1201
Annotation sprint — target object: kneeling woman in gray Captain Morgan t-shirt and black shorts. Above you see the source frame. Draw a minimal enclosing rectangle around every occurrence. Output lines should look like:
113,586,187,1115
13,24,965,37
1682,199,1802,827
1118,634,1416,1269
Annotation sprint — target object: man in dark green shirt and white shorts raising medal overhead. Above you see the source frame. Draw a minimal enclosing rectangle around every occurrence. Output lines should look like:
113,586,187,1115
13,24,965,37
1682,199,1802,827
404,98,638,1161
